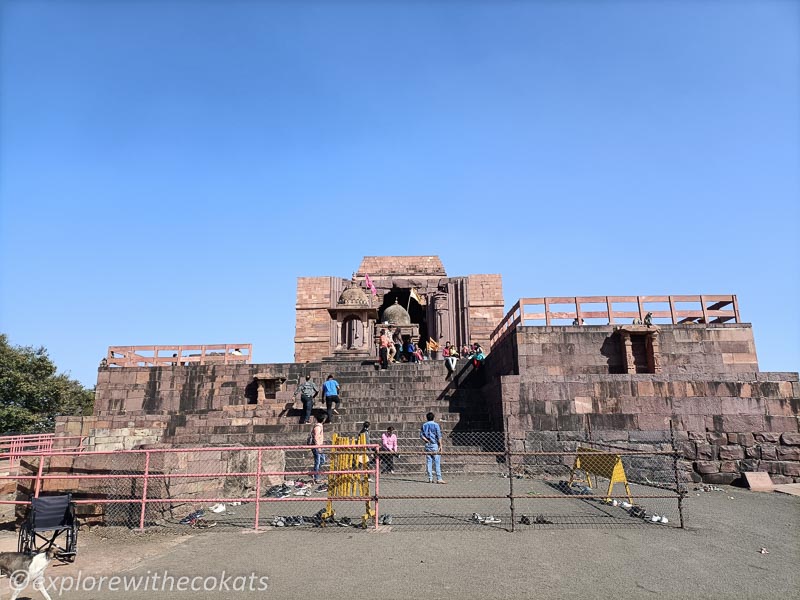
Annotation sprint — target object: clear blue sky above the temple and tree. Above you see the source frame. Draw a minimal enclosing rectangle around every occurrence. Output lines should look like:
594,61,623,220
0,0,800,385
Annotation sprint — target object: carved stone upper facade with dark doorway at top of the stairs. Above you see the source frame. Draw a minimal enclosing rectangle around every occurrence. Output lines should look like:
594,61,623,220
295,256,505,362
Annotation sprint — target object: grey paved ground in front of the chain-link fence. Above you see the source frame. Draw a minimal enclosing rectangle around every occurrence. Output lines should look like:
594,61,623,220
0,487,800,600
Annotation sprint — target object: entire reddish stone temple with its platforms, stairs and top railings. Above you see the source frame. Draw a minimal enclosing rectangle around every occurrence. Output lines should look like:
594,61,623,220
57,256,800,483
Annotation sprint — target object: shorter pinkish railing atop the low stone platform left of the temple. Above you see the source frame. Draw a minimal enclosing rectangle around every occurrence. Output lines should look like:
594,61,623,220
101,344,253,367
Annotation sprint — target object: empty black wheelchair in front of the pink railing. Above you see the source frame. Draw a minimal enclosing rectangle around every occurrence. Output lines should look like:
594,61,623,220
19,494,78,562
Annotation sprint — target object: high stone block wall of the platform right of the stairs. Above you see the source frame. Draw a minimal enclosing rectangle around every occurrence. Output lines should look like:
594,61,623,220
486,325,800,483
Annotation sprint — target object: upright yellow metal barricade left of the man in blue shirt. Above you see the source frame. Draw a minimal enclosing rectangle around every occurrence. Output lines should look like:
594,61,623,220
321,433,375,527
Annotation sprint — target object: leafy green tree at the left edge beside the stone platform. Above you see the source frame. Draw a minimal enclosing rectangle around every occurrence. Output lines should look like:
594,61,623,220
0,334,94,434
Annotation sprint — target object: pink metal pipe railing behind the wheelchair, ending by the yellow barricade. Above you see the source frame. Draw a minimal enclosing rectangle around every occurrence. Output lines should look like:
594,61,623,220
0,446,380,529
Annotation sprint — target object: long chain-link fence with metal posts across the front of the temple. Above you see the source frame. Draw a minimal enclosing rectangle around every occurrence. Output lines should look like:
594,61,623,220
1,431,683,530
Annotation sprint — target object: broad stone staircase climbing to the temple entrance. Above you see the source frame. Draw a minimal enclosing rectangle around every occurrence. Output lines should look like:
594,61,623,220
163,360,491,446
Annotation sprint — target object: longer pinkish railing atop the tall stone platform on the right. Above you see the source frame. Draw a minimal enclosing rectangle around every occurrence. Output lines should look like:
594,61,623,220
491,295,740,346
